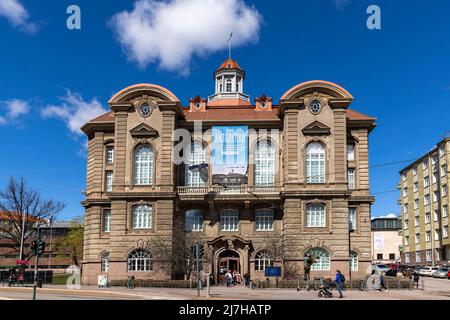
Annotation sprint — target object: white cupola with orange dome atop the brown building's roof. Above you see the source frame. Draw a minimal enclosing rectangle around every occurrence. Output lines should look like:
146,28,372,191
208,58,251,107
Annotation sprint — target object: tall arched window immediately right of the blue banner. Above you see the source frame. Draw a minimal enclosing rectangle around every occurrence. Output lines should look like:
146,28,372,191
254,141,275,186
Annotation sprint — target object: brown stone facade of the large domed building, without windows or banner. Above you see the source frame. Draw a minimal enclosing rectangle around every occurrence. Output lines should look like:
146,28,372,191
82,61,375,284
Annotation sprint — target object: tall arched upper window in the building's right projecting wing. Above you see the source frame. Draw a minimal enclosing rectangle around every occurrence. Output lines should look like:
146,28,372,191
306,142,325,183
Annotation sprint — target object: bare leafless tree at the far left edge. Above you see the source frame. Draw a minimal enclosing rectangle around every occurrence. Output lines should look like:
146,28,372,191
0,177,65,259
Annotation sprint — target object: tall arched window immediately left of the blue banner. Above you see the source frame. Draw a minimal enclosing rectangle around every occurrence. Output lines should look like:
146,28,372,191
184,142,208,187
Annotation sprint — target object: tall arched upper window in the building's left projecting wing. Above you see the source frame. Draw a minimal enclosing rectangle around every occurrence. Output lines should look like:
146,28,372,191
134,145,153,185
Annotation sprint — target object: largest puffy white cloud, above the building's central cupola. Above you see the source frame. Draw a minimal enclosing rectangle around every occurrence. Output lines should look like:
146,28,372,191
110,0,262,75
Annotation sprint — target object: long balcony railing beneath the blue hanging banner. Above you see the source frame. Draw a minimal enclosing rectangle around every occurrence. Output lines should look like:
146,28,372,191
178,186,281,196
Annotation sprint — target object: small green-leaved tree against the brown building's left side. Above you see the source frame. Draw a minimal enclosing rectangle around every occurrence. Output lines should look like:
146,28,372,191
55,216,84,266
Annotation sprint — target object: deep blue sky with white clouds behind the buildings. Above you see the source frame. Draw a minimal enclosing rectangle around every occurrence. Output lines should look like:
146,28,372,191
0,0,450,219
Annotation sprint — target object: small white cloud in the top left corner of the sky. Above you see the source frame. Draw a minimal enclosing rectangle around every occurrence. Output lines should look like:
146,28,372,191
0,0,38,33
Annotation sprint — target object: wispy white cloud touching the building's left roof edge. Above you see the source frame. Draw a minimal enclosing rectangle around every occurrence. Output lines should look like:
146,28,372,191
41,90,108,135
